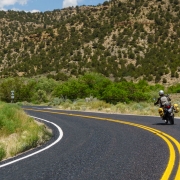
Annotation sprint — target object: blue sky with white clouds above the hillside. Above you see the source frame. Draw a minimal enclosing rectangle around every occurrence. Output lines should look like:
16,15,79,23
0,0,108,12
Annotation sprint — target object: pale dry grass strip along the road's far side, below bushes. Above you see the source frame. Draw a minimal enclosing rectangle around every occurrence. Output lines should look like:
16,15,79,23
56,94,180,116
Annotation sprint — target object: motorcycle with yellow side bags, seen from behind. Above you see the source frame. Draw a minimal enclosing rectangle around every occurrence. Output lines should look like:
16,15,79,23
159,103,179,125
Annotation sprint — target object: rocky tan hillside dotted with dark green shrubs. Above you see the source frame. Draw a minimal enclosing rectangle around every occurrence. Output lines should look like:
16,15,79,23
0,0,180,85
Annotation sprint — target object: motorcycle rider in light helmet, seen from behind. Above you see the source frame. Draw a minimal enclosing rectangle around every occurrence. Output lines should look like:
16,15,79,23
154,90,171,119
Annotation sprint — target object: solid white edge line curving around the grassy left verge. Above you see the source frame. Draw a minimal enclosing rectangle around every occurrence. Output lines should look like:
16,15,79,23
0,116,63,168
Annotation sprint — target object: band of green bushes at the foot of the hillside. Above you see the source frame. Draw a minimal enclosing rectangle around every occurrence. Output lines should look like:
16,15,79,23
0,72,166,106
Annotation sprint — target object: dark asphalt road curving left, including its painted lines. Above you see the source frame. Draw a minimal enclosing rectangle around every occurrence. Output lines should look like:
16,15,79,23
0,107,180,180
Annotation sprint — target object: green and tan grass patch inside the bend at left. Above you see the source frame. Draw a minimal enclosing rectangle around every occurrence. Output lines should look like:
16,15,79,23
0,102,51,160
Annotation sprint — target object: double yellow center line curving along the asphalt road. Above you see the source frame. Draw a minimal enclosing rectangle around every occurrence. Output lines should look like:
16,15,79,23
25,109,180,180
